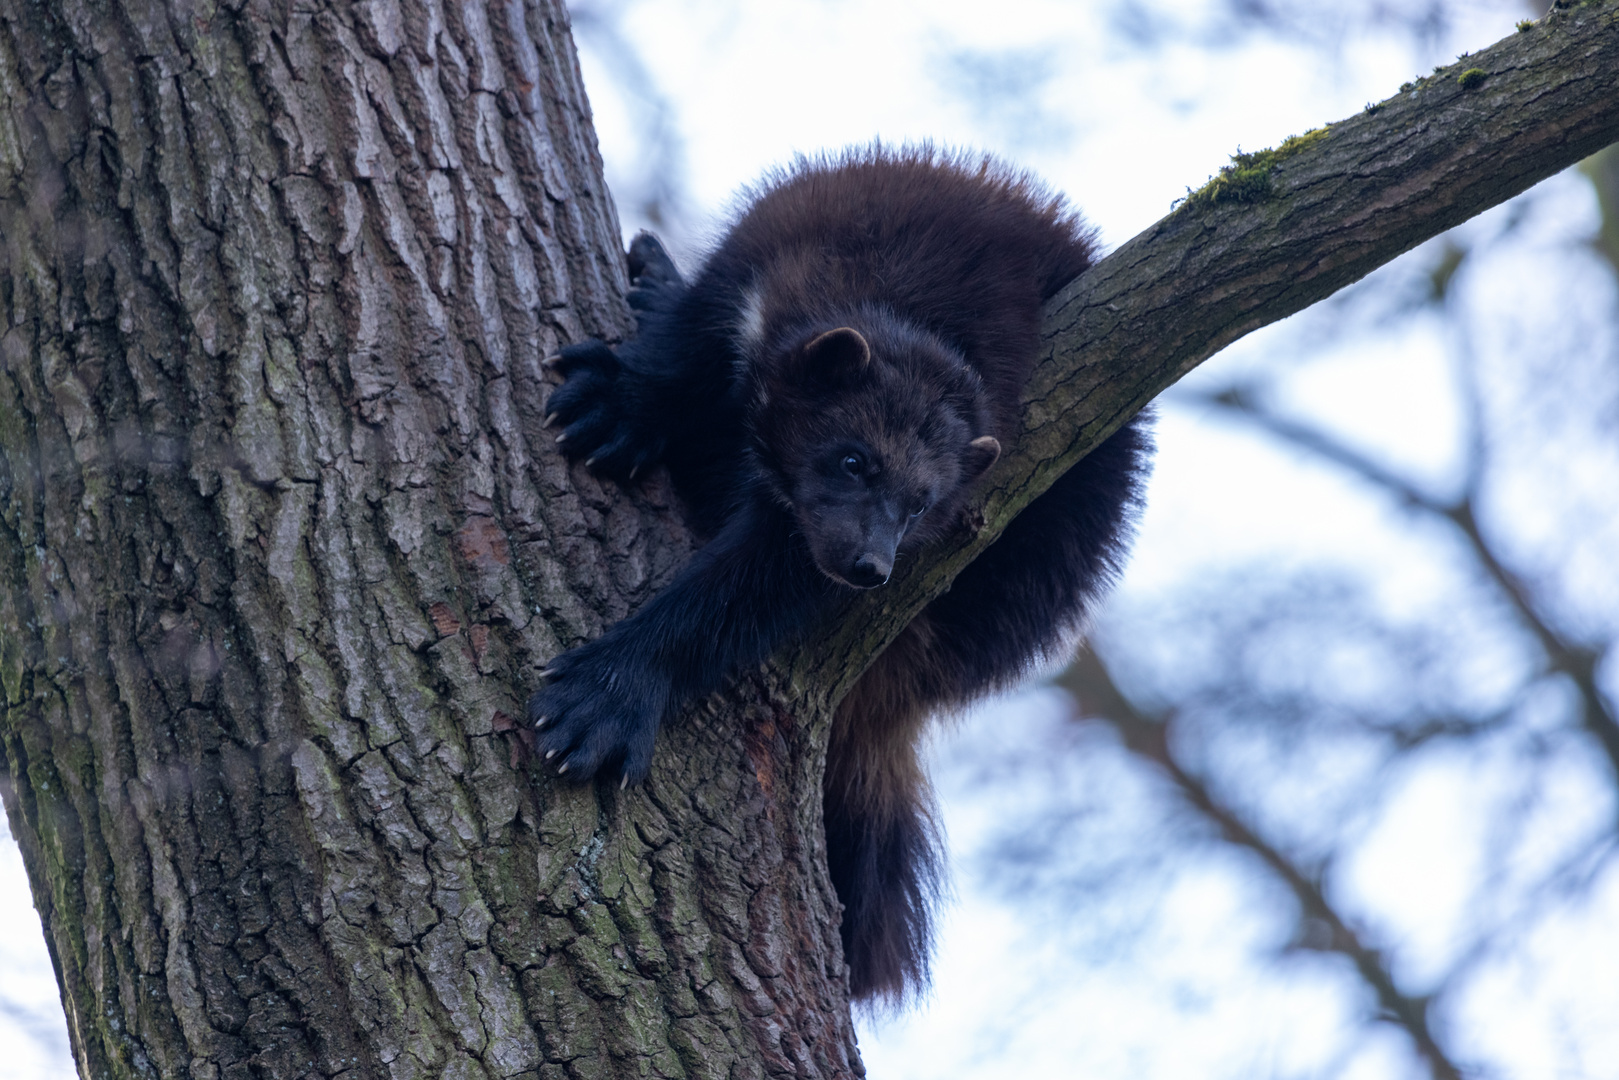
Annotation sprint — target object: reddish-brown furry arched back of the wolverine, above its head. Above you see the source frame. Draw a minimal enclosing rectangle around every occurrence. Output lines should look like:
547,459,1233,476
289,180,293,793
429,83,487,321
715,146,1094,439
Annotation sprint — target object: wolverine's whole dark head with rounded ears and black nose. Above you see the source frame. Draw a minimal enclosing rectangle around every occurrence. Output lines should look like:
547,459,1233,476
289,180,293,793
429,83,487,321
750,313,1001,589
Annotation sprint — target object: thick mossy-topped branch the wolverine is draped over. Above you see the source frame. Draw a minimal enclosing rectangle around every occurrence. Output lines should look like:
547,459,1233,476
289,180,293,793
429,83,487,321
792,0,1619,701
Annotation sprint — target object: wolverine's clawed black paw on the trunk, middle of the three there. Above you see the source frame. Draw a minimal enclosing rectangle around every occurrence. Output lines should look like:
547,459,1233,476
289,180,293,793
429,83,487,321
546,342,664,481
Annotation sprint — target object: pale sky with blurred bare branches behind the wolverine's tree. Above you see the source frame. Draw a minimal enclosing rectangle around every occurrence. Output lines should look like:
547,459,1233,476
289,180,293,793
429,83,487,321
0,0,1619,1080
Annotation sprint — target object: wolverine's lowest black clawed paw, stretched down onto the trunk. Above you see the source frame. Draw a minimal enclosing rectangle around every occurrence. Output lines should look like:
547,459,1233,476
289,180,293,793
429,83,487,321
528,643,669,785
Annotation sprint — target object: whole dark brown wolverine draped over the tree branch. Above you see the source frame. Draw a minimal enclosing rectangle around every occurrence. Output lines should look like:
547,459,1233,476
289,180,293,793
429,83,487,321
529,149,1148,999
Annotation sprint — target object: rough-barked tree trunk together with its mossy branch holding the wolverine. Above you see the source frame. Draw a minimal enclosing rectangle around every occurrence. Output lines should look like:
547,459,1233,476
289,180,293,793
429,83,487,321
0,0,1619,1078
